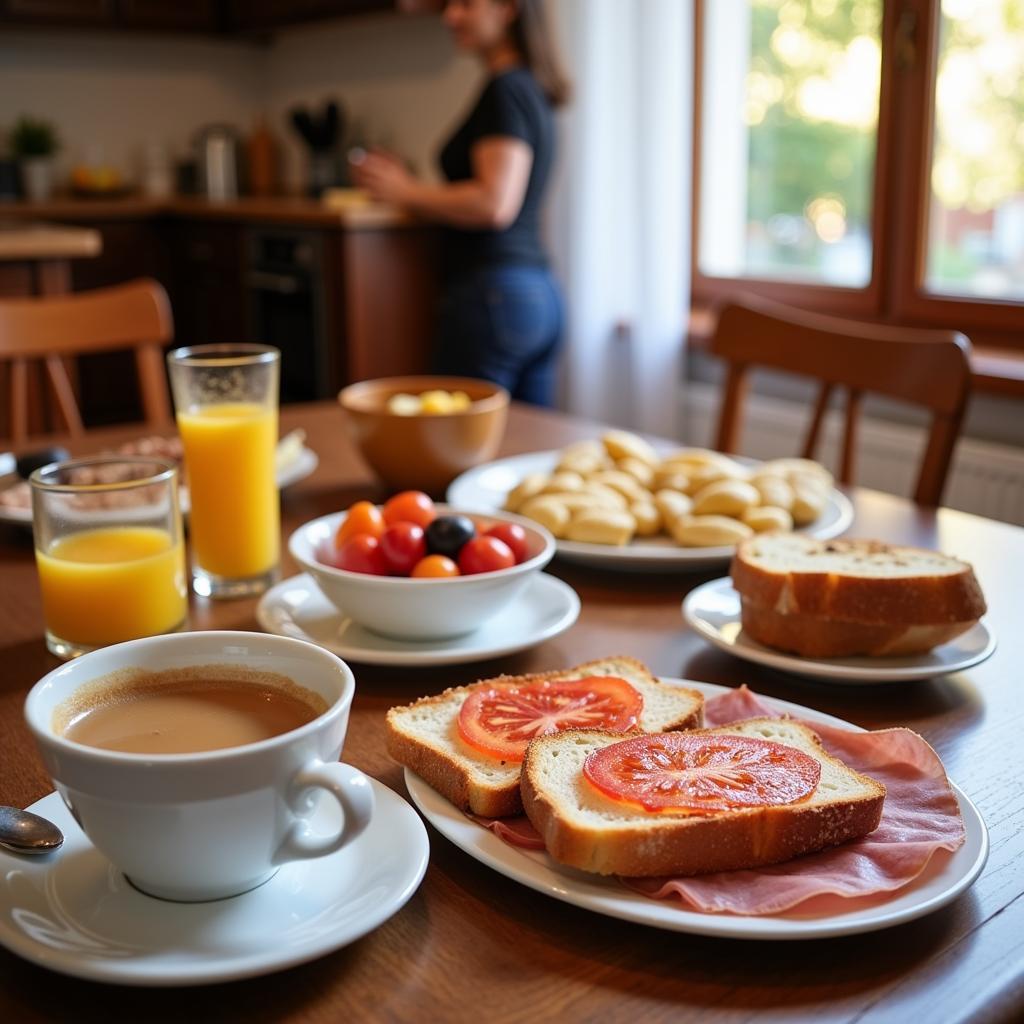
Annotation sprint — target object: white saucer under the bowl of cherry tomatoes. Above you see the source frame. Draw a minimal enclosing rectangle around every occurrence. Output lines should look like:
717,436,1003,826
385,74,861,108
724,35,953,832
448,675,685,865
256,572,580,666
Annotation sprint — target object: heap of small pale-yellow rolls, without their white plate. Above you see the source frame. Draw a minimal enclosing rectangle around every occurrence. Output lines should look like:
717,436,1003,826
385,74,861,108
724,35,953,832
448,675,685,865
505,430,833,548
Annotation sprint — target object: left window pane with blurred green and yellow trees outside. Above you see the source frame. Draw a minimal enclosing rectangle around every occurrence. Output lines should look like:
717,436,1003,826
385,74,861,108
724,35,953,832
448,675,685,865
697,0,882,288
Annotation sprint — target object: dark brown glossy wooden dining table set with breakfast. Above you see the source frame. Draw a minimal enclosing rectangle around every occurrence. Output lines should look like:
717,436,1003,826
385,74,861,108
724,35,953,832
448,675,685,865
0,402,1024,1024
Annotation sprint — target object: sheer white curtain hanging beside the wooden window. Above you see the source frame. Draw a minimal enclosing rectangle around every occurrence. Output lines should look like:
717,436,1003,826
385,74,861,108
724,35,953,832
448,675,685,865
551,0,693,436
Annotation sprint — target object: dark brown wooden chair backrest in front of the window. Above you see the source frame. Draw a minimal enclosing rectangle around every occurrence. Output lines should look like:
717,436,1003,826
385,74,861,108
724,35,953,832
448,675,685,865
711,298,971,505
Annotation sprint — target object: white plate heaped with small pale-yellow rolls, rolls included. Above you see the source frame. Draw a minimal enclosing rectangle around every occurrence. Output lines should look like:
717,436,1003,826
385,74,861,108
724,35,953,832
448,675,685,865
447,430,853,572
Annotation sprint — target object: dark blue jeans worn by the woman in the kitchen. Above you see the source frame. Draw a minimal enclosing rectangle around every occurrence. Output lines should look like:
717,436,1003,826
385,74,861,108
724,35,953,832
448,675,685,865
434,266,563,406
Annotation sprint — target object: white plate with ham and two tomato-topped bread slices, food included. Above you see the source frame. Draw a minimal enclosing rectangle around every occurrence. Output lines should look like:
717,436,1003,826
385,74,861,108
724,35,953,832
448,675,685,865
395,671,988,939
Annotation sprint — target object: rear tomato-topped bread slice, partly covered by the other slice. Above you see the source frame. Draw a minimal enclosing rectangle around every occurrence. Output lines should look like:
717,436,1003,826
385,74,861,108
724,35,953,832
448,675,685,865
386,656,703,818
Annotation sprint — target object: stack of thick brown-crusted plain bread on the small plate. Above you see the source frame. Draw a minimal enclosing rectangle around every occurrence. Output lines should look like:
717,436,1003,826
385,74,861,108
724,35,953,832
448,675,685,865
730,534,986,657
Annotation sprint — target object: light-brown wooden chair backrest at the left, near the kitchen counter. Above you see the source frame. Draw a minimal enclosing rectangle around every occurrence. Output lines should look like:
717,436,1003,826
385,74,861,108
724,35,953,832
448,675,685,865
0,279,174,441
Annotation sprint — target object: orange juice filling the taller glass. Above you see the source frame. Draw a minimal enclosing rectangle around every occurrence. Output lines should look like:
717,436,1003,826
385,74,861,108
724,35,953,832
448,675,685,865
178,402,281,579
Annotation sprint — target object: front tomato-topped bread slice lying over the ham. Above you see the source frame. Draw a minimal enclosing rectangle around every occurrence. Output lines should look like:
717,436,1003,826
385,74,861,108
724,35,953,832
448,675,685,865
521,718,886,878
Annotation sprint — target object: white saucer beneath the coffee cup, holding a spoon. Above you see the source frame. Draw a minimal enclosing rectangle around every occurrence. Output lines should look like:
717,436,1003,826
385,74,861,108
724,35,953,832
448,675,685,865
0,779,430,985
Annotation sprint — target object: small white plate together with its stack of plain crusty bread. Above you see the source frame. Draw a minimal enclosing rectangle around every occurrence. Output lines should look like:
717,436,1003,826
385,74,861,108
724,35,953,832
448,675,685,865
683,534,995,683
